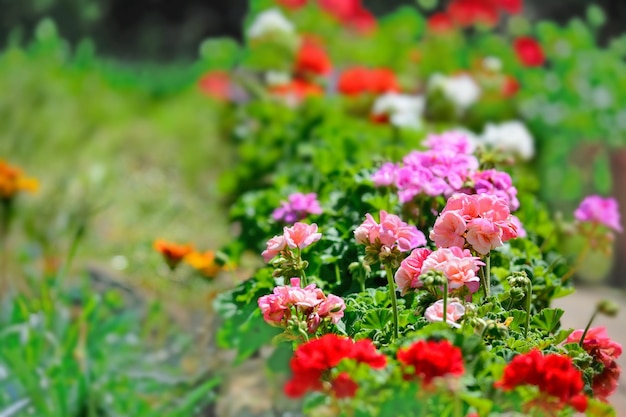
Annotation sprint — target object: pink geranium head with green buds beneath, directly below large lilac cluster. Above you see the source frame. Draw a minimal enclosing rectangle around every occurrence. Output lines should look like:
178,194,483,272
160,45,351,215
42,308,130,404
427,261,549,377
354,210,426,264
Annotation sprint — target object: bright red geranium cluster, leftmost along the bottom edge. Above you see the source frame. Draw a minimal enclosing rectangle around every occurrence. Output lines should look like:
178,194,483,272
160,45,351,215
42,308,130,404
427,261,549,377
284,334,387,398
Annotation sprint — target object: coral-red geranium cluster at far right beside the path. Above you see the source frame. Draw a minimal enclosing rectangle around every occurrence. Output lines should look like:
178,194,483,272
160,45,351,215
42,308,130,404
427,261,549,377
565,327,622,401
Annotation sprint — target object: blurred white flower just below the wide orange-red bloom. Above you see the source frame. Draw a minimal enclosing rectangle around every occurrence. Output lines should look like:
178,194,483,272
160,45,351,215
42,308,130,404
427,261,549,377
372,93,425,129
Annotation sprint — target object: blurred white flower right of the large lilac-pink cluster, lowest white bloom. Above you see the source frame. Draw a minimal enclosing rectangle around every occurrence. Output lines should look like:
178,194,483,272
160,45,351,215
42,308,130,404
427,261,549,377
481,120,535,160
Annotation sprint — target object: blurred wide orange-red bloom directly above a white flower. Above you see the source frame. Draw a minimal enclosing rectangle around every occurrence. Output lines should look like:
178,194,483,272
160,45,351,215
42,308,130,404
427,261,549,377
337,67,399,96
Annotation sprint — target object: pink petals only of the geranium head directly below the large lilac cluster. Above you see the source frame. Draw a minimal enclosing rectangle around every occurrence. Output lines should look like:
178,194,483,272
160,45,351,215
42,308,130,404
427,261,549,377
354,210,426,252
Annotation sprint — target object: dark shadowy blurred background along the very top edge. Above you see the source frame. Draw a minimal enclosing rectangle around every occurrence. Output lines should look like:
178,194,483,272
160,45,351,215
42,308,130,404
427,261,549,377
0,0,626,63
